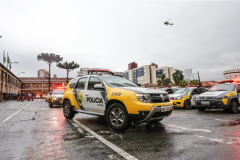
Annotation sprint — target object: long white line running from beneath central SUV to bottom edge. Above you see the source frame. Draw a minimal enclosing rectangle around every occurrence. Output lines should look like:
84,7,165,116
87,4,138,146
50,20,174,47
73,119,137,160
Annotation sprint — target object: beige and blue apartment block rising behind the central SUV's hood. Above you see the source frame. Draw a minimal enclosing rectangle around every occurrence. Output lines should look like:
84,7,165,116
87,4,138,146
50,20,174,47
123,62,174,85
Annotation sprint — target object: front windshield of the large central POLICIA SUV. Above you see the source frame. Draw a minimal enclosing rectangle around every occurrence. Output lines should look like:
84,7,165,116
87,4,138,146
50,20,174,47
101,76,137,87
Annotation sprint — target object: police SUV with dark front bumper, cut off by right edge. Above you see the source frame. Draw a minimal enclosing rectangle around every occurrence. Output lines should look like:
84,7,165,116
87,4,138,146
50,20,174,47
197,79,240,114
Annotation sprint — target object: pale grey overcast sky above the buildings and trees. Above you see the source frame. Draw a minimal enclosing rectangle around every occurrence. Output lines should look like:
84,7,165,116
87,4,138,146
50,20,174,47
0,0,240,80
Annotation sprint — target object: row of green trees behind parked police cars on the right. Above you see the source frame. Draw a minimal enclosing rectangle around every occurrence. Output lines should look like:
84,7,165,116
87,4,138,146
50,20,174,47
157,69,202,87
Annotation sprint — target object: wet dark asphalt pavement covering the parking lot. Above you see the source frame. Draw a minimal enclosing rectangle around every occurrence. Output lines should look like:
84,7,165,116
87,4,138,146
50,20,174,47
0,100,240,160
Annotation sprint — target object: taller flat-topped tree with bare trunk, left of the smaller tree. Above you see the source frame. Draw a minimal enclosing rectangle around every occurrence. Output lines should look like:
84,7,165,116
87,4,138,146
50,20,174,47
37,53,63,92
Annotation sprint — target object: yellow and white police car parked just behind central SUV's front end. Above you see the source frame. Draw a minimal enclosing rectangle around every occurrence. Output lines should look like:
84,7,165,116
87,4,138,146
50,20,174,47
169,87,206,109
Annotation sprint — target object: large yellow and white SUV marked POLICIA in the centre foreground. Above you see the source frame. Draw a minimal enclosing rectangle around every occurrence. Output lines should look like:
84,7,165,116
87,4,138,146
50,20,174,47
62,69,173,131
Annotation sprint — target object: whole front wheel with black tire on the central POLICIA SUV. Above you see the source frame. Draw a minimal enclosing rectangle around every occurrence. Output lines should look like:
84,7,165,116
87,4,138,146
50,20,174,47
106,103,132,131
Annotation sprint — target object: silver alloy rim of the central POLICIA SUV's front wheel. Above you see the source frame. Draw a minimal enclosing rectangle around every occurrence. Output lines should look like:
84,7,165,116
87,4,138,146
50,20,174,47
109,108,125,127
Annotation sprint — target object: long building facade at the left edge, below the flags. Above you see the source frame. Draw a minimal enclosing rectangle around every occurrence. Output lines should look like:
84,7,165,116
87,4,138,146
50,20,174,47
0,63,21,102
